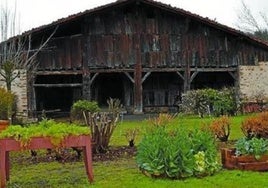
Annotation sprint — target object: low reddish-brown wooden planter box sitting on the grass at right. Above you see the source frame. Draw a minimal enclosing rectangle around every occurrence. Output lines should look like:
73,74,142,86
221,148,268,171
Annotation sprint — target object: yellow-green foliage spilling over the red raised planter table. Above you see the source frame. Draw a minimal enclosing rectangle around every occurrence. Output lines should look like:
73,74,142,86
0,119,89,146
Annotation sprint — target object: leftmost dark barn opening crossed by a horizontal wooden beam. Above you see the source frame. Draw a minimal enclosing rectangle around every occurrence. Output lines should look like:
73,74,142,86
34,74,82,113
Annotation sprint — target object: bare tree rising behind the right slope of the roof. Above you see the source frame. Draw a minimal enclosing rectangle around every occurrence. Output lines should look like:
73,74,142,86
236,0,268,40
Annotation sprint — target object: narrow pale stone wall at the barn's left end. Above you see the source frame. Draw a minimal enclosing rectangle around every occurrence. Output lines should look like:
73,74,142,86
0,70,28,117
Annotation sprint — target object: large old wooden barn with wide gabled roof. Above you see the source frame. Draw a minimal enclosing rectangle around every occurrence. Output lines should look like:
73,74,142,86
0,0,268,115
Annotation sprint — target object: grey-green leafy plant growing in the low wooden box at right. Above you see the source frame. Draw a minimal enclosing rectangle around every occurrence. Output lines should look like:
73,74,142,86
235,137,268,160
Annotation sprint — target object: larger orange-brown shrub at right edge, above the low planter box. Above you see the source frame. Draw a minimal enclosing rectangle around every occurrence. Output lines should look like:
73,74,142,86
241,112,268,138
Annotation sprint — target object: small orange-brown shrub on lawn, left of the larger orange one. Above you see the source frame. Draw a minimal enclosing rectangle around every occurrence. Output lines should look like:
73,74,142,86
209,116,231,142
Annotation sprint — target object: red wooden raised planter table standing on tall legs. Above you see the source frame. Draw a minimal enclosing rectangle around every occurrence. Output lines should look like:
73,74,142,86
0,135,93,188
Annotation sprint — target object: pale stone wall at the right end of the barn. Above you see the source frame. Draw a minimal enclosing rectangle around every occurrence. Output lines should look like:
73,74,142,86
239,62,268,102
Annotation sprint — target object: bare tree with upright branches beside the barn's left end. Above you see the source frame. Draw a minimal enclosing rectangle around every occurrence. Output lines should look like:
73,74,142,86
0,0,57,90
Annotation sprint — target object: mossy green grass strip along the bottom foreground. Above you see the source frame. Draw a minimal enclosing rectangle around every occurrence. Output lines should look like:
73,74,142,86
8,158,268,188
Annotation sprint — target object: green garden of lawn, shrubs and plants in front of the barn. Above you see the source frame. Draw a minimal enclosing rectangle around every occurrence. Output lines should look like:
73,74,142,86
0,89,268,187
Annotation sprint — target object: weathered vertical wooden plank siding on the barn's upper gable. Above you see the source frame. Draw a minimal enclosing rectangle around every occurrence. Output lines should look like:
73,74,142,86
36,7,268,70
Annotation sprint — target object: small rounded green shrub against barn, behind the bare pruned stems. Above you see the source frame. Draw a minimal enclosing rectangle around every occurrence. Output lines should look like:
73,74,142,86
71,100,100,120
